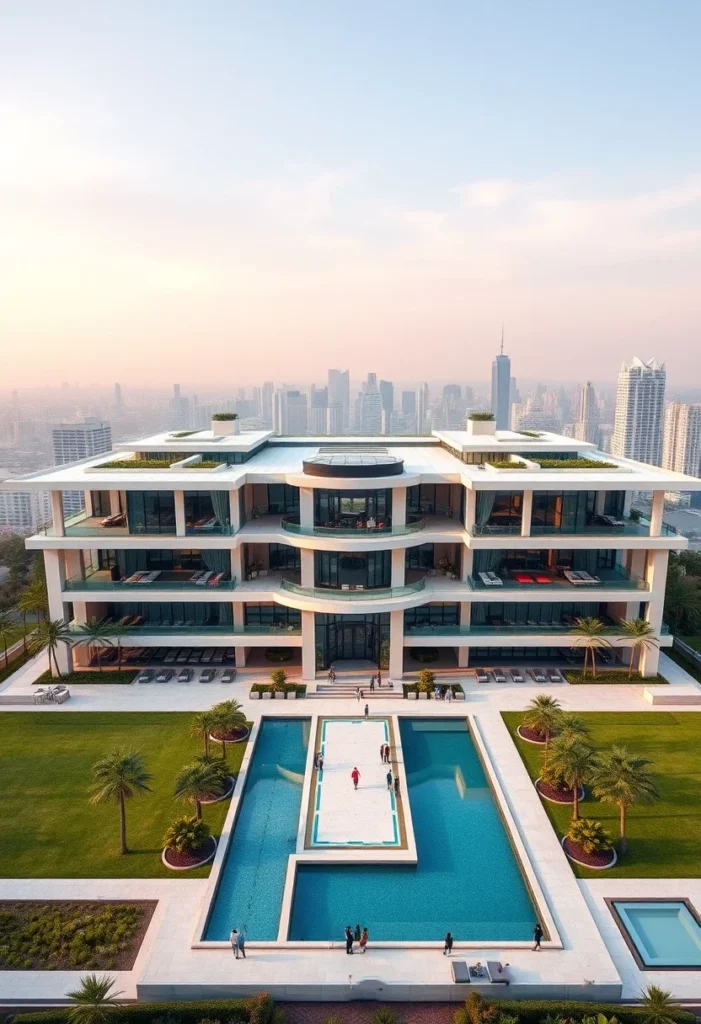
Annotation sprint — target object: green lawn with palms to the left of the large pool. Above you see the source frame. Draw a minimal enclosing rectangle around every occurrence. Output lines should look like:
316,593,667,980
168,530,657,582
0,711,246,879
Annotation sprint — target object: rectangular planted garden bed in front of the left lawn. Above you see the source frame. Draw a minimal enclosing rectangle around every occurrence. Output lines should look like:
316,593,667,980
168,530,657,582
0,900,156,971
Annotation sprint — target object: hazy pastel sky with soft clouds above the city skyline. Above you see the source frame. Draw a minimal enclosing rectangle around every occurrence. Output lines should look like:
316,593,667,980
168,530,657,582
0,0,701,386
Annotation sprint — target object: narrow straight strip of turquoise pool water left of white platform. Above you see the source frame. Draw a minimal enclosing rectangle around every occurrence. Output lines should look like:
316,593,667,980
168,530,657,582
204,719,310,941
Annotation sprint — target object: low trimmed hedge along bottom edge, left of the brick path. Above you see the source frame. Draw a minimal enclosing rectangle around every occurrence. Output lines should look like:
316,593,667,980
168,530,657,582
15,994,276,1024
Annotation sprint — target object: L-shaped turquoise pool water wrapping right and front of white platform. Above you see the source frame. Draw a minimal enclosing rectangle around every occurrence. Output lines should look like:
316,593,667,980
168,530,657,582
290,719,536,941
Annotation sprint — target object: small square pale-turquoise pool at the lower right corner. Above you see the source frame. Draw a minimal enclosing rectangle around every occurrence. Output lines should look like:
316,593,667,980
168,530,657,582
606,899,701,971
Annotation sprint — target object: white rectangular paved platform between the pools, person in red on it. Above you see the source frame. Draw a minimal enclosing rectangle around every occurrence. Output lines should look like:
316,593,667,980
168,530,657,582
312,718,399,846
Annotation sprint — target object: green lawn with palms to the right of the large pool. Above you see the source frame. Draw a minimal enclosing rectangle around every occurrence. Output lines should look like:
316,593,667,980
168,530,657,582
501,712,701,879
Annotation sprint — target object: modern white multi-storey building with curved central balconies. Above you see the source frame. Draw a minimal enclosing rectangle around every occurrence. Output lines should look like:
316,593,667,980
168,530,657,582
3,421,701,680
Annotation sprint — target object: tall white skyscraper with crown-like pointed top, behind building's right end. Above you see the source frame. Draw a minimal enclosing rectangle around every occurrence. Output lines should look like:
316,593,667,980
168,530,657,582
611,356,666,466
